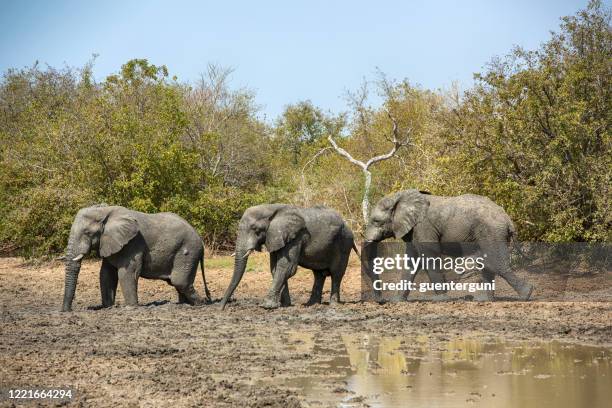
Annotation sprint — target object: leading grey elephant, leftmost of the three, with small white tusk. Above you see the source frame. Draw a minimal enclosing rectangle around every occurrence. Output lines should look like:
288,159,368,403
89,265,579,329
62,205,210,311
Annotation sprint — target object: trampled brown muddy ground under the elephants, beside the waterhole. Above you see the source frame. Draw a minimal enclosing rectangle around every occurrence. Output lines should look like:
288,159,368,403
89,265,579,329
0,254,612,407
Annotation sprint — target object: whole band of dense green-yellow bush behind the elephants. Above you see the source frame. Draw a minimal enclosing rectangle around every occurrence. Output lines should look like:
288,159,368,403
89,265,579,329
0,1,612,256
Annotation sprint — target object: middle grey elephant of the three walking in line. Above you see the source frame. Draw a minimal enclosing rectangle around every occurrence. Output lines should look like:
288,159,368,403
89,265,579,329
221,204,357,309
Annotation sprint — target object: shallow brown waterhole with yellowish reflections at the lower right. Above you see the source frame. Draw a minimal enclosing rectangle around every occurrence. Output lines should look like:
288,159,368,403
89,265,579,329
274,332,612,408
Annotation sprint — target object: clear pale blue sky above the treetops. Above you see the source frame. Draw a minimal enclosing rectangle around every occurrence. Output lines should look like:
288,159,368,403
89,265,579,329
0,0,592,120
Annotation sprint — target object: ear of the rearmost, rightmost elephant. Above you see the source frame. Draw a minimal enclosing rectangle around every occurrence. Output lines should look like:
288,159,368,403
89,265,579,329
391,190,429,239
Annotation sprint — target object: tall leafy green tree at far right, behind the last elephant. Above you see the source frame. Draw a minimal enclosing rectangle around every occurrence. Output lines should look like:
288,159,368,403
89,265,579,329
448,1,612,241
